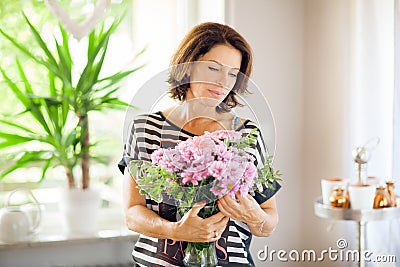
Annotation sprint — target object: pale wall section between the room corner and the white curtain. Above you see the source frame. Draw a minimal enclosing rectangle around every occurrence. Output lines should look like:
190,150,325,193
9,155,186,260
301,0,357,266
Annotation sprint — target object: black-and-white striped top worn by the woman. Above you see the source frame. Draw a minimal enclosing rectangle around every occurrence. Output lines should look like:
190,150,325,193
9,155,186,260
118,112,280,266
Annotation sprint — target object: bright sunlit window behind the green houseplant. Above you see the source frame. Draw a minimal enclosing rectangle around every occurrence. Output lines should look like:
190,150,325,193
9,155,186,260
0,0,224,210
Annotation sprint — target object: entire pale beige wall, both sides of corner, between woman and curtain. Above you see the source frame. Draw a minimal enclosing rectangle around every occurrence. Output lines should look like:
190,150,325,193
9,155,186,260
226,0,356,266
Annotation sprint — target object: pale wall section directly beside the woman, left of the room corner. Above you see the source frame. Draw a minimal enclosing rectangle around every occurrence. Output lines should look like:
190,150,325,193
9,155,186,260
226,0,304,266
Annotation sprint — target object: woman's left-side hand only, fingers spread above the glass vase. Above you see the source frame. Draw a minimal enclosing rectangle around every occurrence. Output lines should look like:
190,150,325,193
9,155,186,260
173,202,229,242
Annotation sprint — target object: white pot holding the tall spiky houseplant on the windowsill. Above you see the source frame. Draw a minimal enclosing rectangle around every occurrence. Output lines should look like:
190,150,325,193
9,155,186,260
59,189,100,237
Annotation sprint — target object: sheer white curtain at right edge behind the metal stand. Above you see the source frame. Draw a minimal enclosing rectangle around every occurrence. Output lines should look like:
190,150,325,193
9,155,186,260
348,0,400,266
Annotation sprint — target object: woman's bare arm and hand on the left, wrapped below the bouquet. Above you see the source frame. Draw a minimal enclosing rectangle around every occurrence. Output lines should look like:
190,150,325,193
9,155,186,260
124,173,229,242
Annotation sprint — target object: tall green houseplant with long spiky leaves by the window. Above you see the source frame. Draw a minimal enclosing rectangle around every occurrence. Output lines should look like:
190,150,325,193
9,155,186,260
0,14,143,189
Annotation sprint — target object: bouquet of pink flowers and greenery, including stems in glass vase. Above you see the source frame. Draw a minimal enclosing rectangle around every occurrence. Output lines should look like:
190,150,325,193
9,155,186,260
128,129,280,266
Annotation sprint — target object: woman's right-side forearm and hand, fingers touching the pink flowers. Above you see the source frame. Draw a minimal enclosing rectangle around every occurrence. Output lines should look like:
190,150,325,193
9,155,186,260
218,193,278,236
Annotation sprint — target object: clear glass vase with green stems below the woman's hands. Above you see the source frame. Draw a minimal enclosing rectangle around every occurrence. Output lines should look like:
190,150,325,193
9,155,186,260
183,242,218,267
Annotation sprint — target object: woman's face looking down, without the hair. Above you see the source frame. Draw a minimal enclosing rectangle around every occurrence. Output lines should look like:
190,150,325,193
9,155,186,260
186,44,242,106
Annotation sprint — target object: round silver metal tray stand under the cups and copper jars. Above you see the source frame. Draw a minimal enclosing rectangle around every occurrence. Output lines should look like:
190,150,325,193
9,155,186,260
314,197,400,267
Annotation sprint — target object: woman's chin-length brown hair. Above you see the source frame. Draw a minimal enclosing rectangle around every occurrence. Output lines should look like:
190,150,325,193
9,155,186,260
168,22,253,112
